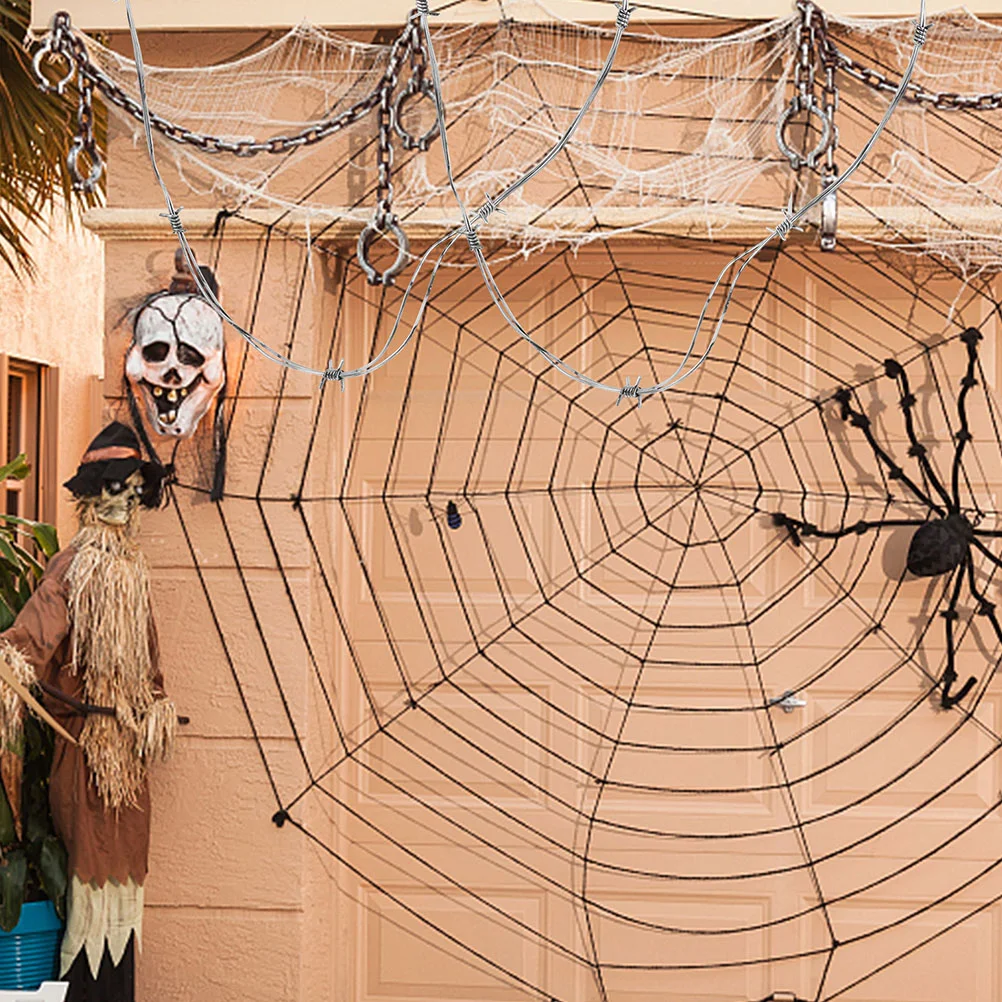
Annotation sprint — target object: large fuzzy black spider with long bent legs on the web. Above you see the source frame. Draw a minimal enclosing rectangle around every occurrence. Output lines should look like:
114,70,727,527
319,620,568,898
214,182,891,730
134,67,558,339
773,327,1002,709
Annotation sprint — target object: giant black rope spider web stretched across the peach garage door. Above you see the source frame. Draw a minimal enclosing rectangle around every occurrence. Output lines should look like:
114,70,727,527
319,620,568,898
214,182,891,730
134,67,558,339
133,223,1002,999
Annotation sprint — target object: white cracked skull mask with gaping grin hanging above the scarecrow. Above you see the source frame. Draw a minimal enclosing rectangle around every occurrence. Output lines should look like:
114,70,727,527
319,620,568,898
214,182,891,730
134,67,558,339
125,252,226,438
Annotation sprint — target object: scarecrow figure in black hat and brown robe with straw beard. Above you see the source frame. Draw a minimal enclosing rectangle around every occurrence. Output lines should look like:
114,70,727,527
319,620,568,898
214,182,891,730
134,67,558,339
0,422,177,1002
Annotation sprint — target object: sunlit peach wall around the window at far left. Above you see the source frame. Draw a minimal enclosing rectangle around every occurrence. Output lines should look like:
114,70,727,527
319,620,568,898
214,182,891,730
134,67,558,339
0,204,104,539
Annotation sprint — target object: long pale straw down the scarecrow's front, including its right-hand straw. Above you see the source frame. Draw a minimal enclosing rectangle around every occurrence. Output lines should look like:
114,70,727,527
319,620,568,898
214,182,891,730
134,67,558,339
67,498,176,809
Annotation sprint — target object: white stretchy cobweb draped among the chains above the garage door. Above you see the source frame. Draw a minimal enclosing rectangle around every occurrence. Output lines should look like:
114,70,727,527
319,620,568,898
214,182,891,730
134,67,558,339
72,2,1002,267
